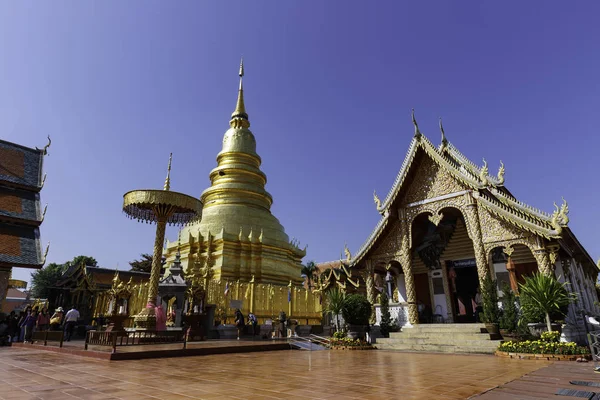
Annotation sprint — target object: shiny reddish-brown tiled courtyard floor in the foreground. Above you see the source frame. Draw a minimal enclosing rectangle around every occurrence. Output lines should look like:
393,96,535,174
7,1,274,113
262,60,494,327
0,347,549,400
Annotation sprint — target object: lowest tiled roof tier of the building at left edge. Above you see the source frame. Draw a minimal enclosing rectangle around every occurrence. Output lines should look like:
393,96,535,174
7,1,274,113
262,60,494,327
0,223,43,267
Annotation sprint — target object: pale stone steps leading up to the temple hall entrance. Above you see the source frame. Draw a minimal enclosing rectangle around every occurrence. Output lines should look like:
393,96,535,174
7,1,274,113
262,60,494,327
376,324,502,354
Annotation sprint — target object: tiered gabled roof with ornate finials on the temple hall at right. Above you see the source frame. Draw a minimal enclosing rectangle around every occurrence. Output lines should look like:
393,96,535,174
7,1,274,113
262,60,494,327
347,119,576,265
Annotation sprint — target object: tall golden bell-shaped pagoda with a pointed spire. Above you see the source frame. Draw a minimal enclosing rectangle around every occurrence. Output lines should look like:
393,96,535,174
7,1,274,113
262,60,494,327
159,60,320,319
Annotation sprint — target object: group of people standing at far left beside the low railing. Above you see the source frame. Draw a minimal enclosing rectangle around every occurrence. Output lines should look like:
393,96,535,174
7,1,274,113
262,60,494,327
0,306,80,344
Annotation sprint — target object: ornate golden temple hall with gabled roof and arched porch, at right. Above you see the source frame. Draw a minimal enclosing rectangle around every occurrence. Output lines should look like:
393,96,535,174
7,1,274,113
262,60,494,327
318,111,600,336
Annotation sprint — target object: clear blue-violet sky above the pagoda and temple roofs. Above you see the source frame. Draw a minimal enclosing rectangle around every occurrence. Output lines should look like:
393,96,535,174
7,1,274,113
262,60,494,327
0,0,600,278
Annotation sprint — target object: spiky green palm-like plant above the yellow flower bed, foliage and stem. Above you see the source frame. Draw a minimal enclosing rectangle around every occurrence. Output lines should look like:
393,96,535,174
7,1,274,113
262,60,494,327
519,273,577,332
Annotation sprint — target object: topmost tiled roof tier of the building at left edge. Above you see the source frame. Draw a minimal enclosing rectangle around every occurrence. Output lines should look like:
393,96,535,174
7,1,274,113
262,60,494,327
0,140,44,190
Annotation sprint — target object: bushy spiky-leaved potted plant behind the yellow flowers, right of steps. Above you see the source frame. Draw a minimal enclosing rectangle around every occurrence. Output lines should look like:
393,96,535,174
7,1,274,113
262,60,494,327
519,273,577,336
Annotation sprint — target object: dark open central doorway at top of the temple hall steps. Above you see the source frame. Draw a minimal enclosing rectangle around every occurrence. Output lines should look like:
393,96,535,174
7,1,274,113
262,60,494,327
446,259,479,323
